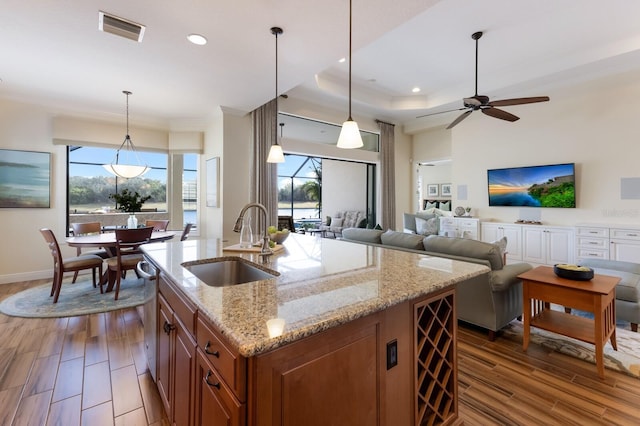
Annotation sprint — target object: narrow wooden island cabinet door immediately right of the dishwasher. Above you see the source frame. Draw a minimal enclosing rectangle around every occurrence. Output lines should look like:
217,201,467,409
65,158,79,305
156,296,173,418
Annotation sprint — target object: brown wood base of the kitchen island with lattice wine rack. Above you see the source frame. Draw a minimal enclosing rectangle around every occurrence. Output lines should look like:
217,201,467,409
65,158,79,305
158,272,457,426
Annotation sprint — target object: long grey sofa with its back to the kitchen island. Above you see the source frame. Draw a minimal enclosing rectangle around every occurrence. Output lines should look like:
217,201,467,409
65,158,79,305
342,228,531,340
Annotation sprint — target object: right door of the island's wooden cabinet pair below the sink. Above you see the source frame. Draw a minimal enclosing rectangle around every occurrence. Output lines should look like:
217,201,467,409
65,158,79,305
170,318,196,426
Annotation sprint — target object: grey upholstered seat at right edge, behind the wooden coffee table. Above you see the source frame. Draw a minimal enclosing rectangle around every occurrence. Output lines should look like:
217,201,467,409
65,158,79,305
580,259,640,332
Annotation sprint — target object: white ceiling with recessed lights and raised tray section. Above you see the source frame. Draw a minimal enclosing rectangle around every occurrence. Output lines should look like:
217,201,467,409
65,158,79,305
0,0,640,133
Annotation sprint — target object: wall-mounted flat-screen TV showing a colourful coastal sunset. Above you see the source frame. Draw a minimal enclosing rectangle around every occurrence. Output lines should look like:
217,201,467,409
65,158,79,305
487,163,576,208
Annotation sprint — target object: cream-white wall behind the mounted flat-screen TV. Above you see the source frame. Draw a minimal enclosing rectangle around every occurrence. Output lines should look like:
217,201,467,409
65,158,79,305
414,68,640,226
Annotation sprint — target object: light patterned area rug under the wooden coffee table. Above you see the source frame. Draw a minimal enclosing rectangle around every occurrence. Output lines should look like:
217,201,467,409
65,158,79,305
503,320,640,378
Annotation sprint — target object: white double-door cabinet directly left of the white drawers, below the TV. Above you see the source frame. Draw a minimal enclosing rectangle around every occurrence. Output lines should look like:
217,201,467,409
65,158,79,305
522,225,574,265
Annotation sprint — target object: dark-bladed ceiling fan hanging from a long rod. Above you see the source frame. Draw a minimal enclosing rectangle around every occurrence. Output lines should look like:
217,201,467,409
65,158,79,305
416,31,549,129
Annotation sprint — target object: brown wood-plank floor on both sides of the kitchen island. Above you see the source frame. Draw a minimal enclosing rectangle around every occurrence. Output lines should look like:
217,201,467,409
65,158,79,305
0,281,640,426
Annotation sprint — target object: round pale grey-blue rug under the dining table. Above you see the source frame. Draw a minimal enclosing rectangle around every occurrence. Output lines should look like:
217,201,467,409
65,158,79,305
0,274,145,318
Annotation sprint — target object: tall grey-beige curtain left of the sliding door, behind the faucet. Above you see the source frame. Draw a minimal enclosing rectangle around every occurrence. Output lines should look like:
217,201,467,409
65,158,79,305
249,99,278,235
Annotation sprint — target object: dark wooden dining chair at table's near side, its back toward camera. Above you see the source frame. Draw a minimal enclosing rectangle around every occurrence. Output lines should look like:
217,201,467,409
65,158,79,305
107,226,153,300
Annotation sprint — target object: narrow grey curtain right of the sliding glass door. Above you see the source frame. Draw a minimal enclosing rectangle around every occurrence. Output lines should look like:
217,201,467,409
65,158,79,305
376,120,396,229
